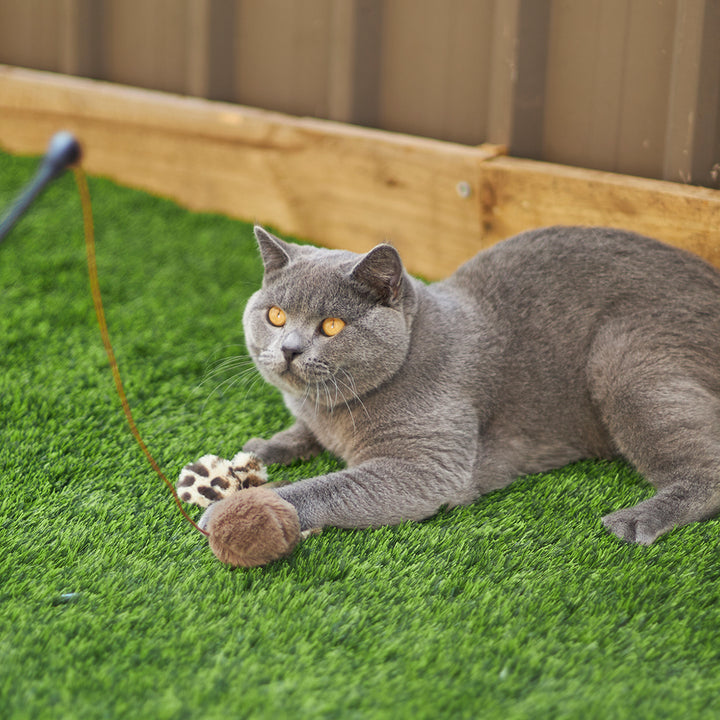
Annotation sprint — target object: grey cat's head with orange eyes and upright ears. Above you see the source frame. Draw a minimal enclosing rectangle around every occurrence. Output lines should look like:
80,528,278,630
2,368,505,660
243,227,416,407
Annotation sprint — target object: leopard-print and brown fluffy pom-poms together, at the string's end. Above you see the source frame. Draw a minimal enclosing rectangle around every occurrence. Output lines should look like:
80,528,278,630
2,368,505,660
176,452,311,567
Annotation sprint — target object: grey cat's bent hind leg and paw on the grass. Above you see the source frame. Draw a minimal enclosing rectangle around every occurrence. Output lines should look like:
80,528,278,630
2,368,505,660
589,324,720,545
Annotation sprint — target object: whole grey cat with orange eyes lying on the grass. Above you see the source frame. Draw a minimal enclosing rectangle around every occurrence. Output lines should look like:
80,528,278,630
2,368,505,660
204,227,720,544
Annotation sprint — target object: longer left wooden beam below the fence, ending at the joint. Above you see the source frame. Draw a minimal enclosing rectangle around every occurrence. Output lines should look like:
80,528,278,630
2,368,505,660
0,67,497,277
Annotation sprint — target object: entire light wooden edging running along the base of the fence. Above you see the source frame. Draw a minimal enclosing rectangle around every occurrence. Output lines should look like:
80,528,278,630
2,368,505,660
0,66,720,278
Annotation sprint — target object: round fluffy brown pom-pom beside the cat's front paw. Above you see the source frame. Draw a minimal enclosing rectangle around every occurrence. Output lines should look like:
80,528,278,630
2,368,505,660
207,487,300,567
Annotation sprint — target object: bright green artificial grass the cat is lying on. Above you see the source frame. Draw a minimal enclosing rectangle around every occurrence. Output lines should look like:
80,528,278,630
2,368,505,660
0,148,720,719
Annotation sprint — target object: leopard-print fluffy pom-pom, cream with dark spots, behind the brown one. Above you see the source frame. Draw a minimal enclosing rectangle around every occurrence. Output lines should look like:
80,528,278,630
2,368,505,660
176,452,267,508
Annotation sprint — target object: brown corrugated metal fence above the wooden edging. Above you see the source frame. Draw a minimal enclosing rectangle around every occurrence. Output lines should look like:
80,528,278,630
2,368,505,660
0,0,720,187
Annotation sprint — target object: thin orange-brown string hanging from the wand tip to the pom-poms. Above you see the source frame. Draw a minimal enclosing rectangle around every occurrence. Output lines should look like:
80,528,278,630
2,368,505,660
73,165,209,536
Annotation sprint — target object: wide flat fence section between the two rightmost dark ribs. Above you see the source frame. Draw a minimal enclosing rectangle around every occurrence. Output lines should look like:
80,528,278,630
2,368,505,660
544,0,679,180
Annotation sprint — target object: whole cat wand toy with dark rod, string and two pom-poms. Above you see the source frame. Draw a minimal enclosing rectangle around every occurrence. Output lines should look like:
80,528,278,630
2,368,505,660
0,131,302,567
